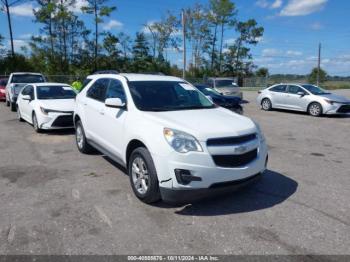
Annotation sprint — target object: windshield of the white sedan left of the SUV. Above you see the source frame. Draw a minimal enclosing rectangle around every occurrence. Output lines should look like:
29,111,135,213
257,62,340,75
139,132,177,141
36,86,76,99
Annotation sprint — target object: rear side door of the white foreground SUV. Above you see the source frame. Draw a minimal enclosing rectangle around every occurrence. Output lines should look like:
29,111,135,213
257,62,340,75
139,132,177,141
84,78,109,145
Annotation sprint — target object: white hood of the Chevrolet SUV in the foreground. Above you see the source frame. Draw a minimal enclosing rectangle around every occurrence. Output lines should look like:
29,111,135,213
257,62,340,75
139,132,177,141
144,108,257,141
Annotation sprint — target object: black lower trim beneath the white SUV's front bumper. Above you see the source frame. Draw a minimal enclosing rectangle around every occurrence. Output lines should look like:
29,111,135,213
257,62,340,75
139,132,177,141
160,173,261,203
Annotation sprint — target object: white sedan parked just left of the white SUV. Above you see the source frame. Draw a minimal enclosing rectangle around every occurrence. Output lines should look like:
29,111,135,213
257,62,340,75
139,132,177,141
17,83,76,132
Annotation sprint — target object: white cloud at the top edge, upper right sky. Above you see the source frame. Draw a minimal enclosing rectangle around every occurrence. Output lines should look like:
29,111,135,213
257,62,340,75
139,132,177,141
280,0,328,16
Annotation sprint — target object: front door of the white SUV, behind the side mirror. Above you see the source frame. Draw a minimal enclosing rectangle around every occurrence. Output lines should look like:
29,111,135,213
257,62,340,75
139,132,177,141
104,79,128,159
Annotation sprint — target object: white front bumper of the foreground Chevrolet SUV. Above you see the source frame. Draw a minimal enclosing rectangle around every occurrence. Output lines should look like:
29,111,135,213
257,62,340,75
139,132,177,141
152,141,267,201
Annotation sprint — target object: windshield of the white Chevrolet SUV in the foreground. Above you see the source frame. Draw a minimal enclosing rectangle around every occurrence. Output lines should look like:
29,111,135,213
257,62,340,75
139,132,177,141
129,81,215,111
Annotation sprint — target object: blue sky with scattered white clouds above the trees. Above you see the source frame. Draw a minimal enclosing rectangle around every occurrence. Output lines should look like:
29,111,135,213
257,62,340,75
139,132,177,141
0,0,350,76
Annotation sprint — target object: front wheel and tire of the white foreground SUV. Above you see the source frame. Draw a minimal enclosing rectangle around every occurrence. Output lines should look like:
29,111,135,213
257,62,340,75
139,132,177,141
128,147,161,204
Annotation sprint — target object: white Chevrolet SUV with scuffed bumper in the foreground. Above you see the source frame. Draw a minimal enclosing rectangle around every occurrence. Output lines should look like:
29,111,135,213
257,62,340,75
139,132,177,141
74,74,267,203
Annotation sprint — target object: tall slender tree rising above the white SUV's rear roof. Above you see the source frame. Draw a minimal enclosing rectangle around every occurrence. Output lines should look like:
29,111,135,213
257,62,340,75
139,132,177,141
81,0,116,70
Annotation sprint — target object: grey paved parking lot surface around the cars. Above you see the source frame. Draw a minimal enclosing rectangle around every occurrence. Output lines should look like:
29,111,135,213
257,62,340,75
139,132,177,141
0,90,350,255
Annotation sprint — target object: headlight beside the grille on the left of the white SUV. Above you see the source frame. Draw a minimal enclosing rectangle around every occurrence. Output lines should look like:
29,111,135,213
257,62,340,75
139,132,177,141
163,128,203,153
